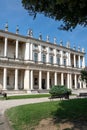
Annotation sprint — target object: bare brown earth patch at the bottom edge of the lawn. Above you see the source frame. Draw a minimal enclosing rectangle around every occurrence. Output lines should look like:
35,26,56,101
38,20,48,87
31,118,87,130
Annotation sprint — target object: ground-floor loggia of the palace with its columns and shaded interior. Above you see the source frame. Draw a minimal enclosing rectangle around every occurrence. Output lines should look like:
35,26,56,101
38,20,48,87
0,68,86,91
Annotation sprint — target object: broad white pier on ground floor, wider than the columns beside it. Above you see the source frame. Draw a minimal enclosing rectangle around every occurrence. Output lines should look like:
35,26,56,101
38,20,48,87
24,70,30,90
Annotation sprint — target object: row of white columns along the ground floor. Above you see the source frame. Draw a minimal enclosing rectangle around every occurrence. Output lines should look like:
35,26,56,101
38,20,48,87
3,68,86,90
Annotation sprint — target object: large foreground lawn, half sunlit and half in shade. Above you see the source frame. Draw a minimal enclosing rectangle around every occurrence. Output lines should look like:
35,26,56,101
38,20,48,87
6,98,87,130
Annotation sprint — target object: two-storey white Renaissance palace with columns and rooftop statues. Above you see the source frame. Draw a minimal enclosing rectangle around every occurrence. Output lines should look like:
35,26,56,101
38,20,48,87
0,25,86,92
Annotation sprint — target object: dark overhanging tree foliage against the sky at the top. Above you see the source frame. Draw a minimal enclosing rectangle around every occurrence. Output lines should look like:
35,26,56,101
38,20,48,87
22,0,87,31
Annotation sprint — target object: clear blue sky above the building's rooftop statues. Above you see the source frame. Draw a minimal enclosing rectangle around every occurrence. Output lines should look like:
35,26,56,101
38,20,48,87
0,0,87,65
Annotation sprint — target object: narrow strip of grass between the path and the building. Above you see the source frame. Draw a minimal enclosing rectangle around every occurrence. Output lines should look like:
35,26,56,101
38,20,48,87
3,94,50,100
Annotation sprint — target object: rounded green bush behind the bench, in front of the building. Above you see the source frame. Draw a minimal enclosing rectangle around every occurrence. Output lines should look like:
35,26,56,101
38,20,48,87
49,85,71,96
